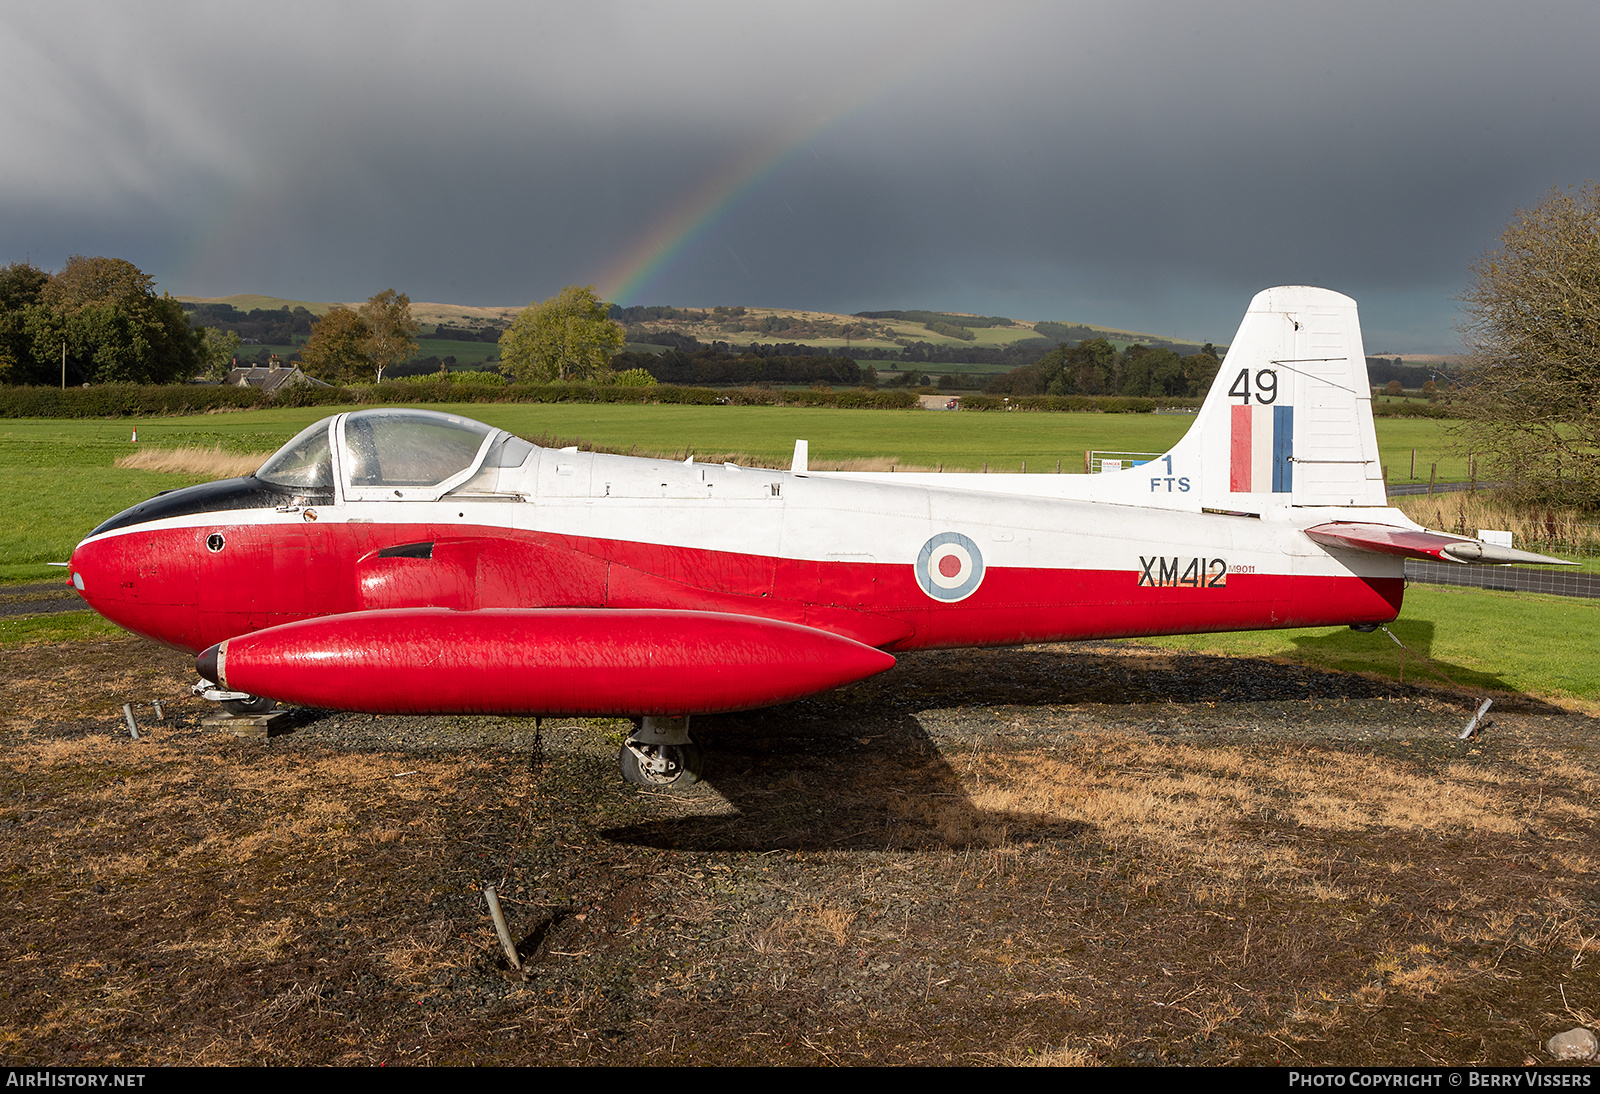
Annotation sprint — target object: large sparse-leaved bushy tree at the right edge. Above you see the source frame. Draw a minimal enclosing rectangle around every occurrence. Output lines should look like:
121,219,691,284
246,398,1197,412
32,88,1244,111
1461,182,1600,509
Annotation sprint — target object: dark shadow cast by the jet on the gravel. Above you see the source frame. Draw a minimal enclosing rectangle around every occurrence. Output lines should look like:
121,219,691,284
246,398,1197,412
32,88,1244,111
603,639,1562,851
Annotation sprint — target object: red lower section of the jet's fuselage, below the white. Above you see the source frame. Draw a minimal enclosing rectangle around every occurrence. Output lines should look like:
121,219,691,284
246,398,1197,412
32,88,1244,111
74,521,1405,653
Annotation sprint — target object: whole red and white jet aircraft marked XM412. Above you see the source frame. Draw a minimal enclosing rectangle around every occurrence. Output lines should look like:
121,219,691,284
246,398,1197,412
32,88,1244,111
70,286,1557,784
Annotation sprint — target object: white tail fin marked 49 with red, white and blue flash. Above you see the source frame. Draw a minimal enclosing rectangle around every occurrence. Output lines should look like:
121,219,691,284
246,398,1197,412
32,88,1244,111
1171,285,1387,510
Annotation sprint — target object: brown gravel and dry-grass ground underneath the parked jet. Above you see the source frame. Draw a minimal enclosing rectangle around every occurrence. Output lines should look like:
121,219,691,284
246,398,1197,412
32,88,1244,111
0,638,1600,1065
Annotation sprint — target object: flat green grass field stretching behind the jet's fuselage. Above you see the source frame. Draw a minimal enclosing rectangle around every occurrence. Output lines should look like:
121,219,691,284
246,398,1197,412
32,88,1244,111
0,403,1450,569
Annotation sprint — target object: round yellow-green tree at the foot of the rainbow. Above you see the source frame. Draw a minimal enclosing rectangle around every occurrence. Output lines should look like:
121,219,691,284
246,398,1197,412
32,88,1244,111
501,285,622,384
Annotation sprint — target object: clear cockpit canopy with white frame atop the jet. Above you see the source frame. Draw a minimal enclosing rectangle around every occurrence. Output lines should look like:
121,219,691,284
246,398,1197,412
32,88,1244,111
256,408,533,501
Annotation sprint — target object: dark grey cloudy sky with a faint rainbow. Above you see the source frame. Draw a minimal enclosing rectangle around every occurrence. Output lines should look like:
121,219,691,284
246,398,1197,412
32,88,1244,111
0,0,1600,353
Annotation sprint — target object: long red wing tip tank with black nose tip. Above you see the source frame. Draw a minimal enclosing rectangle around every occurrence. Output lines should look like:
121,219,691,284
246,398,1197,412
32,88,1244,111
197,608,894,717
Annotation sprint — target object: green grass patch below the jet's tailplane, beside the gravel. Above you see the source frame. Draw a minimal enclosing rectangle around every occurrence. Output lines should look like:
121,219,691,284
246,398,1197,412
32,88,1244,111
1139,585,1600,702
